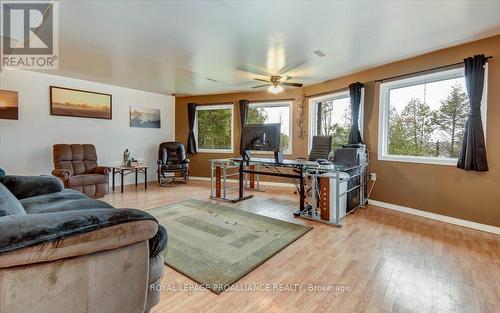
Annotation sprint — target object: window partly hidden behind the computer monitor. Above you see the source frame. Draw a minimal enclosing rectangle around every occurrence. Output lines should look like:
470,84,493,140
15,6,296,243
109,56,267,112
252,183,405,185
247,101,292,154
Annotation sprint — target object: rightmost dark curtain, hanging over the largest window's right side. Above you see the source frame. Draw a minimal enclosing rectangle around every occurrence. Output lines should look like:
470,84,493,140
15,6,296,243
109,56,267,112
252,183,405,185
457,55,488,171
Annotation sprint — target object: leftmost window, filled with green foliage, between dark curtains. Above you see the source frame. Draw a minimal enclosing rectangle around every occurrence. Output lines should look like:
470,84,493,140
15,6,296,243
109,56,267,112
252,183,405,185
194,104,233,152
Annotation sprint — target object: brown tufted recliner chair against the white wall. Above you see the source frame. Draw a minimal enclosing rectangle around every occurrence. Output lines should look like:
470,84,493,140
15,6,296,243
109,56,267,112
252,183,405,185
52,144,109,198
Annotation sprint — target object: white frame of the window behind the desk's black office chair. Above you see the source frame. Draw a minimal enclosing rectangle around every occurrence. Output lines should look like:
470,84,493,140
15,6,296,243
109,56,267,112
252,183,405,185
307,87,365,151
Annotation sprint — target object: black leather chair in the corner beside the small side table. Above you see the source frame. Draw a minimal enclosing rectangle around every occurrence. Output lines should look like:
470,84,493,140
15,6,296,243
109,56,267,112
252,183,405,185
158,141,189,186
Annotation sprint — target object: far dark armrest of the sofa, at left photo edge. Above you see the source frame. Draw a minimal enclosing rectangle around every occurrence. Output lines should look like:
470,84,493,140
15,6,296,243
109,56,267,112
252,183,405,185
0,175,64,199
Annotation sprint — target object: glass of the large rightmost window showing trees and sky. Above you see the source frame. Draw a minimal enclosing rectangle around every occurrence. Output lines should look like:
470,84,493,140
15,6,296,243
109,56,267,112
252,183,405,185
388,78,469,159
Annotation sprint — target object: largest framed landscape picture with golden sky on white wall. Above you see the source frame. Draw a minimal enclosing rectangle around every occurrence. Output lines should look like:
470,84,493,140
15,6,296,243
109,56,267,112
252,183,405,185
50,86,112,120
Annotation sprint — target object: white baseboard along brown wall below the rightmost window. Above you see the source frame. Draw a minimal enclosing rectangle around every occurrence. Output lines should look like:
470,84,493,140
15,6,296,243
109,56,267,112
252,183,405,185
368,199,500,235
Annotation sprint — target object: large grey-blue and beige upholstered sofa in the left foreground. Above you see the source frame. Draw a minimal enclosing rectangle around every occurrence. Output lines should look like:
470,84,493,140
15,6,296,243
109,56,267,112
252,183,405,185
0,176,167,313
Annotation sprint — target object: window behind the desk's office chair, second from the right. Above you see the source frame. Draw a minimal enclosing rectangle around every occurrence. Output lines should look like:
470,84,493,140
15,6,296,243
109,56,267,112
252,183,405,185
309,88,364,150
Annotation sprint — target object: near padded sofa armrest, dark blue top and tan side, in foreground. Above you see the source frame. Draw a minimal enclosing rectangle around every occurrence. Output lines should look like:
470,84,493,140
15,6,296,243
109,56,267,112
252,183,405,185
0,209,158,268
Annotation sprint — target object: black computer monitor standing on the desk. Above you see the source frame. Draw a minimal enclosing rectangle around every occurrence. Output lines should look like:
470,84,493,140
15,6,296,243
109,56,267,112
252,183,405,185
241,123,283,162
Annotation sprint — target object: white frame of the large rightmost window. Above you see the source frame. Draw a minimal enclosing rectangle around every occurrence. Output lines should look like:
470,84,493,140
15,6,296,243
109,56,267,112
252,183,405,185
378,65,488,166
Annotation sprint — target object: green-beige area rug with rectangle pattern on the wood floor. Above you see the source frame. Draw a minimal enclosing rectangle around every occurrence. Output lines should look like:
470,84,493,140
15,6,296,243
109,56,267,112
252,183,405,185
148,200,312,294
